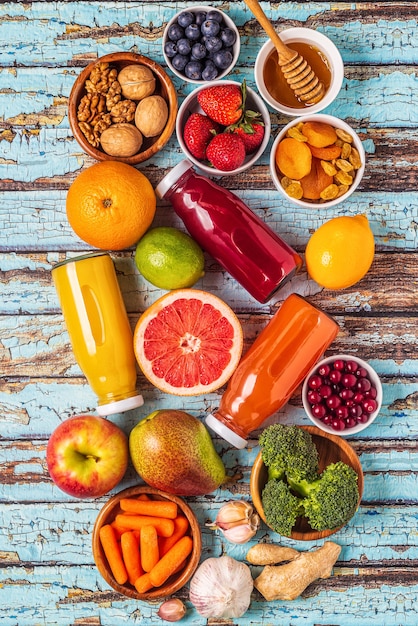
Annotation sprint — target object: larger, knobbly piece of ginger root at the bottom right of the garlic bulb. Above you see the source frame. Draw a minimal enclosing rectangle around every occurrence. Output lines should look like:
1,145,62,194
254,541,341,601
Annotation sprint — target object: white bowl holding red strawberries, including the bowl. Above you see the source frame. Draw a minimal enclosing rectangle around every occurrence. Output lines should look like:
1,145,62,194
176,80,271,177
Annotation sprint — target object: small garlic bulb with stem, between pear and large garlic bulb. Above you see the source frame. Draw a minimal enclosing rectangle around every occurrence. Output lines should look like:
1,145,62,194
207,500,260,543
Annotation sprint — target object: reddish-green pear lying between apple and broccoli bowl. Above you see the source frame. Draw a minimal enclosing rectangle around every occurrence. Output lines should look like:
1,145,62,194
129,409,226,496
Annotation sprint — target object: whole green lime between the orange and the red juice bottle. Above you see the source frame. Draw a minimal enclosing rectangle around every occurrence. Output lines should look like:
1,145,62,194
135,226,205,290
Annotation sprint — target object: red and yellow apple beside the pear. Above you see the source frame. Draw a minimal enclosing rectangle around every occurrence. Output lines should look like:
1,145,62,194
46,415,129,498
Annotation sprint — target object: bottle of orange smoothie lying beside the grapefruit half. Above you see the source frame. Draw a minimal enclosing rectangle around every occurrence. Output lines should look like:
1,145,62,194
206,294,339,448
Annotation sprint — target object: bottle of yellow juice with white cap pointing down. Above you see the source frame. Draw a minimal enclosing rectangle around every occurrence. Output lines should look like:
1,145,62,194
52,252,143,416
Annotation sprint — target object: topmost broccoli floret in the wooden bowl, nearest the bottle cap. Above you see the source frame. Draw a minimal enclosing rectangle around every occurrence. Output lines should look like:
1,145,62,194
259,424,318,482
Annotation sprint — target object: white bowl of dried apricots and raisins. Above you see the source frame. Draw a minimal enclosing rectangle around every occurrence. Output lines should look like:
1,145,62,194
270,113,366,208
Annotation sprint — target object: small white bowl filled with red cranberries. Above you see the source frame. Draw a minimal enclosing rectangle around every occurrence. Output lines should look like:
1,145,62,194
302,354,383,437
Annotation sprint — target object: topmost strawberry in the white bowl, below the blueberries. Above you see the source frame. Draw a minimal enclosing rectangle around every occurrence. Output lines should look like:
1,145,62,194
197,85,244,126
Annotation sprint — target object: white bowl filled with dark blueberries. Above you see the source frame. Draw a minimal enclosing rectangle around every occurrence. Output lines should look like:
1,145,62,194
163,6,240,84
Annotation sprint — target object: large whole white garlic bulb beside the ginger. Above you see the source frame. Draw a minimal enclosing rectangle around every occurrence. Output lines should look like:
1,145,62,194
190,556,254,618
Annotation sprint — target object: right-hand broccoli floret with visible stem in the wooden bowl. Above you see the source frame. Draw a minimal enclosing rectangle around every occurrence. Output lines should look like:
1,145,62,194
289,461,359,530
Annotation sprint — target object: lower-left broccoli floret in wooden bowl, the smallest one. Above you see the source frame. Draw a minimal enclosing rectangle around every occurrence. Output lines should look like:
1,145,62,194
261,478,303,537
